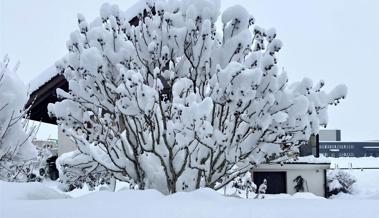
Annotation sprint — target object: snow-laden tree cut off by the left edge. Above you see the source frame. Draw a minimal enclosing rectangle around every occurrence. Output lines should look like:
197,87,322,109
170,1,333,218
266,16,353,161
0,56,37,181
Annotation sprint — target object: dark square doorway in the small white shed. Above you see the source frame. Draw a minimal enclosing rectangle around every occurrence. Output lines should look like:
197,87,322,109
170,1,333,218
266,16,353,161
253,172,287,194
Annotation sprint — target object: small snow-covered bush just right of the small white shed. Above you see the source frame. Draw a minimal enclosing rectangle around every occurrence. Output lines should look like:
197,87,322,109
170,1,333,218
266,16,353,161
327,169,357,196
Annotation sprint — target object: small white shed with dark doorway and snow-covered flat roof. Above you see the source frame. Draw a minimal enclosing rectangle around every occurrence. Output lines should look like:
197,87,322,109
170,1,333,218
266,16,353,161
251,155,330,197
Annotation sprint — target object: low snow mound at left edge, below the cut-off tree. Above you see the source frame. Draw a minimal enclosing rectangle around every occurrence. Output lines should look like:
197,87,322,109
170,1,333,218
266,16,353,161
0,181,69,200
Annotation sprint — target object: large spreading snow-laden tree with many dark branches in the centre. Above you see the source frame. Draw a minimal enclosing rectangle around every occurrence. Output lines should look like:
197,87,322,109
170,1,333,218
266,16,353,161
49,0,346,193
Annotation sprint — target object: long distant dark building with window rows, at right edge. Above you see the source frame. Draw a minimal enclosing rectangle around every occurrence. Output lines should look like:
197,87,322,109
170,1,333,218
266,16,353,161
319,130,379,157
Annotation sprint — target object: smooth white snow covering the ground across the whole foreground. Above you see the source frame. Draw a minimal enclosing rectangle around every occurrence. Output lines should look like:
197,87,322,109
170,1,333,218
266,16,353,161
0,158,379,218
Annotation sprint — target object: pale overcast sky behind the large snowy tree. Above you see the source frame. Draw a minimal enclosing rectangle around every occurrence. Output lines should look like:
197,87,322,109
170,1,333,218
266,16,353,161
0,0,379,141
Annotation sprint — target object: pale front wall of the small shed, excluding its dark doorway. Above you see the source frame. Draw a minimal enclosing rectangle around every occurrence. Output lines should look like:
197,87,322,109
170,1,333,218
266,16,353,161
252,163,330,197
